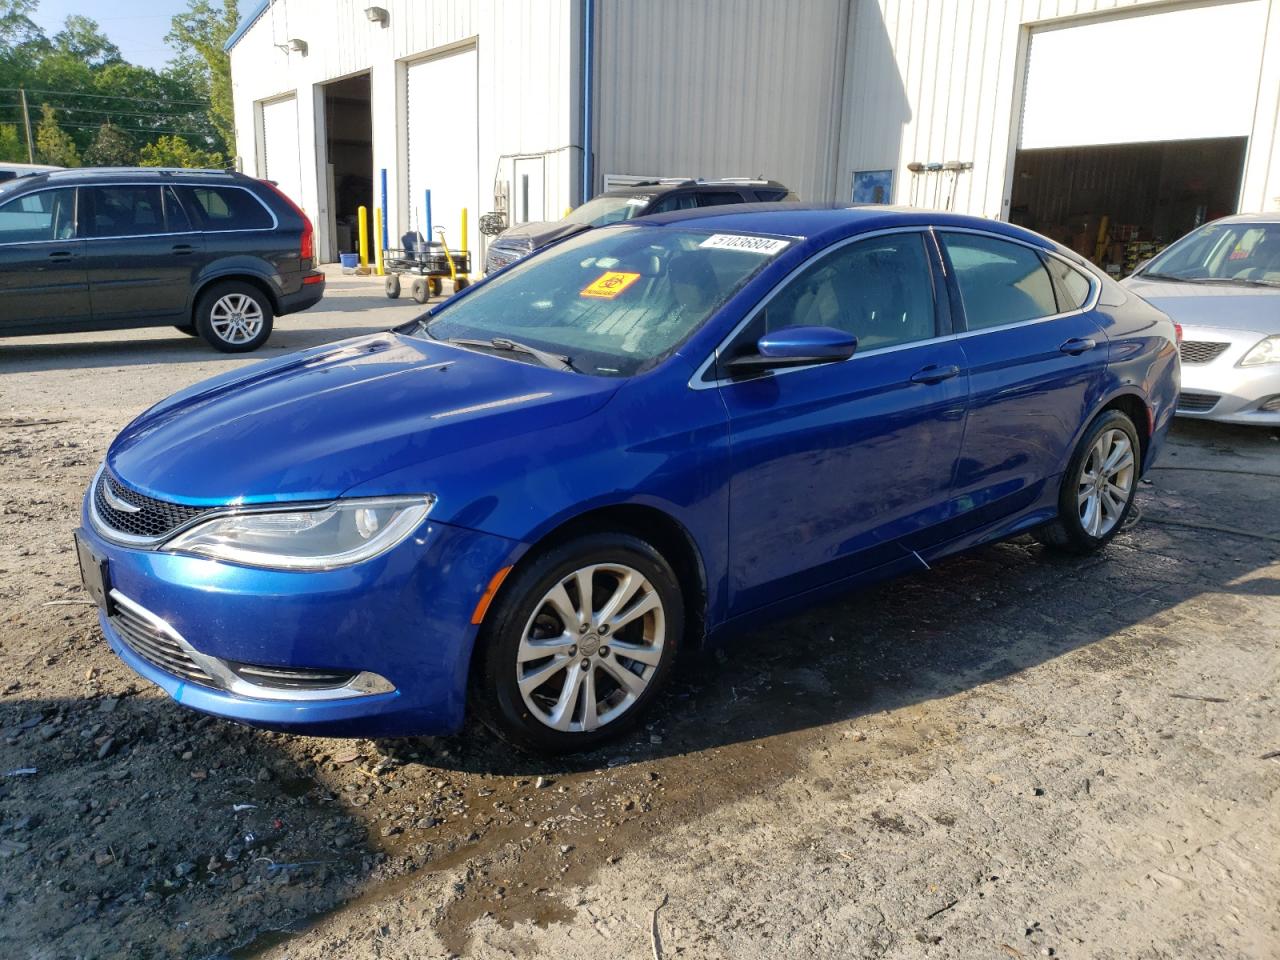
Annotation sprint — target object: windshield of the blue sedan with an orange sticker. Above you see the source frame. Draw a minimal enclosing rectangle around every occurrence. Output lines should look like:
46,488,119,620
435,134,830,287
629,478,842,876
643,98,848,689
417,225,790,376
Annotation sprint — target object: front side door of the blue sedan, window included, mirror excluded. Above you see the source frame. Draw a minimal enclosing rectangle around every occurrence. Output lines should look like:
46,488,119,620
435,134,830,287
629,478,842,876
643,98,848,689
719,230,968,616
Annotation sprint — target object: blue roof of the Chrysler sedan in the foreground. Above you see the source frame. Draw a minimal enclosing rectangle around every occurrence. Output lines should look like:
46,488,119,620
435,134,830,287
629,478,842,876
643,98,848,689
626,202,1057,250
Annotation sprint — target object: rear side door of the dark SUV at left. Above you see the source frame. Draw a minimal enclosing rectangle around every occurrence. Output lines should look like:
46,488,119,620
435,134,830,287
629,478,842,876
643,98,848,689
82,183,205,325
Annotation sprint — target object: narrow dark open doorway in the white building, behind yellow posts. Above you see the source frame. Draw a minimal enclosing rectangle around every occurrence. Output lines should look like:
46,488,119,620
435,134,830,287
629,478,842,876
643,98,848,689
324,73,374,260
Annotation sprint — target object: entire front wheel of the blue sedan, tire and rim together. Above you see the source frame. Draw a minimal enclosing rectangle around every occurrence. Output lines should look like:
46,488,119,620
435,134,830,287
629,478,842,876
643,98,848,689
472,534,685,754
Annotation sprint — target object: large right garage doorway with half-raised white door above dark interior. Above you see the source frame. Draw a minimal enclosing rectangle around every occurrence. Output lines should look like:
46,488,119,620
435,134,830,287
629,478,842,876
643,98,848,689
1007,0,1267,276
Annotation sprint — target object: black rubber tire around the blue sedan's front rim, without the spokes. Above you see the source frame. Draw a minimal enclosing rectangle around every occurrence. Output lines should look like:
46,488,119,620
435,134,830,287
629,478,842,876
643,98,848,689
470,534,685,754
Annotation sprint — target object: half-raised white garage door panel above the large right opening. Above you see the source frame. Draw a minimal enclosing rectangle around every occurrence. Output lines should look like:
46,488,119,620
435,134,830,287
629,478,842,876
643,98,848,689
1018,0,1266,150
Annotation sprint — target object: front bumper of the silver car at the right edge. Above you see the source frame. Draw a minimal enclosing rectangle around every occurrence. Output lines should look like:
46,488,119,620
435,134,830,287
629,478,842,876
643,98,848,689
1178,326,1280,426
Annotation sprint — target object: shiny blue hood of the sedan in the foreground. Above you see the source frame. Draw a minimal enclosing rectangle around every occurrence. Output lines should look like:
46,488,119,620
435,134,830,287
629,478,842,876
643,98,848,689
106,333,621,506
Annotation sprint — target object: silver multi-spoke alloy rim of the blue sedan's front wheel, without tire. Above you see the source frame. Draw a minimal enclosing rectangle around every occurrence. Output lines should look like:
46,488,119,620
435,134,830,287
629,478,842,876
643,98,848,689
516,563,667,732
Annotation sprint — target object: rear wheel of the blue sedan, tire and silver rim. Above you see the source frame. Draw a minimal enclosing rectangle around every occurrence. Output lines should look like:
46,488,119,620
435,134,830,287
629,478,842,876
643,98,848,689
1036,410,1142,553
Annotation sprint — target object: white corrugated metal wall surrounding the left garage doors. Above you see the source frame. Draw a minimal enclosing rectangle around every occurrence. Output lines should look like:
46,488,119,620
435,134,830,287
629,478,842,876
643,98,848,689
232,0,581,263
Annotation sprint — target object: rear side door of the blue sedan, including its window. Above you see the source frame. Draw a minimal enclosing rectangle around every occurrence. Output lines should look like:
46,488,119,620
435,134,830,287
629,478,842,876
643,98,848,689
938,230,1107,531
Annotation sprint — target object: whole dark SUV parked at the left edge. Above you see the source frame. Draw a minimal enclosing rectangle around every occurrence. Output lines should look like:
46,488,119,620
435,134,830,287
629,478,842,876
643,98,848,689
0,168,324,353
